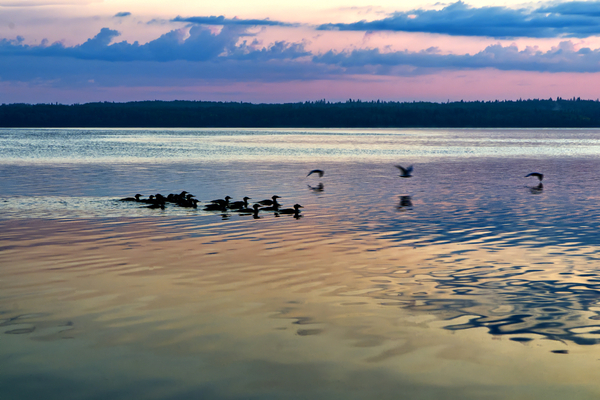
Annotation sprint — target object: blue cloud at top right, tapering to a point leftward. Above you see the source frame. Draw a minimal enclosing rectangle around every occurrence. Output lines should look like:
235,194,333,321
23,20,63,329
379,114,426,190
317,1,600,39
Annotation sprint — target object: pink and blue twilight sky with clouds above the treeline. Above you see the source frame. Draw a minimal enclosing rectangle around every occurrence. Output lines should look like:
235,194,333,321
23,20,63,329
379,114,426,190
0,0,600,104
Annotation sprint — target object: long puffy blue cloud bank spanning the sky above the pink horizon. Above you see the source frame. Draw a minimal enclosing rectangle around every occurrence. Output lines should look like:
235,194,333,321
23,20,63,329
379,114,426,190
0,25,600,96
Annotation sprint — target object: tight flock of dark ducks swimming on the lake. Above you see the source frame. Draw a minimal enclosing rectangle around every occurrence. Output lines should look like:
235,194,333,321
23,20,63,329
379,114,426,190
119,190,303,218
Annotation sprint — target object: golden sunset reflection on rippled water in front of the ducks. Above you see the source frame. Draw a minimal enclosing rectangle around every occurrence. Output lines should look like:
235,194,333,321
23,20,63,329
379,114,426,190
0,218,600,399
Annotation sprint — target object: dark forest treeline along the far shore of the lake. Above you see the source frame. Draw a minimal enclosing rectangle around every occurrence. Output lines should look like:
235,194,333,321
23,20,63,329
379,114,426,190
0,98,600,128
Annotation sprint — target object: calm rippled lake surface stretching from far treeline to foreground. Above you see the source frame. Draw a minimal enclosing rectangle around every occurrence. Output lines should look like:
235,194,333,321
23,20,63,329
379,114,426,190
0,129,600,400
